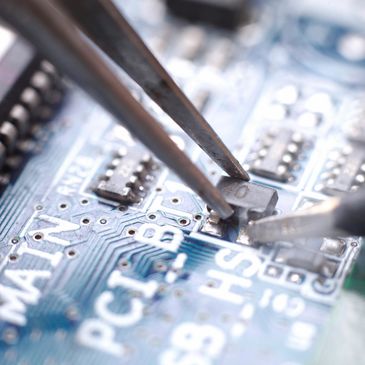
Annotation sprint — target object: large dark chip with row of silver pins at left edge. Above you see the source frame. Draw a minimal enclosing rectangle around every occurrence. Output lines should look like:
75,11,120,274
0,27,63,190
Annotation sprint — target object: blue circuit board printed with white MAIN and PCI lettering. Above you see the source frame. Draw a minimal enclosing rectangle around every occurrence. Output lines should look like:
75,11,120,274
0,0,365,365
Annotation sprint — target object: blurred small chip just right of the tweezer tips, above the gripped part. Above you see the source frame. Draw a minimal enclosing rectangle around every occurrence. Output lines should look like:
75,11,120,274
247,129,307,182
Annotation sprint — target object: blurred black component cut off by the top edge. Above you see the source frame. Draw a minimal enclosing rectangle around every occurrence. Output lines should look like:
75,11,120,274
167,0,249,29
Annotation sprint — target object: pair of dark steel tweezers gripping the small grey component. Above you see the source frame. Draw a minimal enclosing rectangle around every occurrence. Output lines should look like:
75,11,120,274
0,0,249,218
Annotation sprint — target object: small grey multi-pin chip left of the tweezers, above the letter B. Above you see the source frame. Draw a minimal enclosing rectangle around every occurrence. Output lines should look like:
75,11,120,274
95,146,153,204
